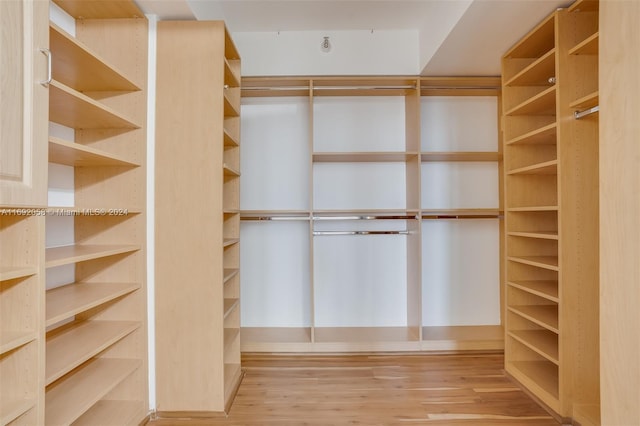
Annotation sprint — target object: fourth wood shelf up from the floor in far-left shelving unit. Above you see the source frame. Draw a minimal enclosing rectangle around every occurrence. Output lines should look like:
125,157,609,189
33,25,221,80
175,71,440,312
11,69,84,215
45,283,140,327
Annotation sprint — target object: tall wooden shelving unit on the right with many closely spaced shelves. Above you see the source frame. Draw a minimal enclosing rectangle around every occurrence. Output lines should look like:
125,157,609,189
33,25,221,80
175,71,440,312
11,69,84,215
502,0,599,424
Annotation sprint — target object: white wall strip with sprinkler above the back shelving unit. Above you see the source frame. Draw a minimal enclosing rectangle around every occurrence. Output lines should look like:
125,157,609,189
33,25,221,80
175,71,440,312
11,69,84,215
233,30,420,76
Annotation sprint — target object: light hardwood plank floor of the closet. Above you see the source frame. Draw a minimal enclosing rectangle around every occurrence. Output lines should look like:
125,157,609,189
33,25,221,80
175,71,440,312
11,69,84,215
148,354,559,426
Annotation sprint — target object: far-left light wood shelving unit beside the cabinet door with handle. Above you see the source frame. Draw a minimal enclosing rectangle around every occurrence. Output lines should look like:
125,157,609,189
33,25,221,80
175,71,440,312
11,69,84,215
42,0,148,425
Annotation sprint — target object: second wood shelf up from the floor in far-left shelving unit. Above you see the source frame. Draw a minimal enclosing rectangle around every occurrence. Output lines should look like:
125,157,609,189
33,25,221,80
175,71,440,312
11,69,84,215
45,358,141,426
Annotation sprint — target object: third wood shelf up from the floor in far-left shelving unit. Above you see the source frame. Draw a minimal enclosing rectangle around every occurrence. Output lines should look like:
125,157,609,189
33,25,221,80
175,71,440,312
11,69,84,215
45,321,140,386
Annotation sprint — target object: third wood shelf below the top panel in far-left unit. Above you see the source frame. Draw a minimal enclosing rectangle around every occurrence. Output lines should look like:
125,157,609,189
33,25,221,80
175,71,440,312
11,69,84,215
49,136,139,167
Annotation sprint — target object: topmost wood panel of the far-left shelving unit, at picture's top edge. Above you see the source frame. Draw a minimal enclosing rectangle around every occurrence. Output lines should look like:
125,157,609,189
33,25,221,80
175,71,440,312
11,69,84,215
53,0,144,19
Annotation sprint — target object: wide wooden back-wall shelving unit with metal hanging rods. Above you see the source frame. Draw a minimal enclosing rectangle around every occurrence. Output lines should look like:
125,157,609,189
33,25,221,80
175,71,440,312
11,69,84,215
241,76,504,352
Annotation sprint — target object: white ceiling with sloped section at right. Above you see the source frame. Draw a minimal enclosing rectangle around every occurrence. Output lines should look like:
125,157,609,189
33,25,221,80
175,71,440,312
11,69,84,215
137,0,572,76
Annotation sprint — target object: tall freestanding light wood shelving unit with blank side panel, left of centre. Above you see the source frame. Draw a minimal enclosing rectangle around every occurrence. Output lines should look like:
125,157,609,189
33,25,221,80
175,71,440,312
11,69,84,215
156,21,242,415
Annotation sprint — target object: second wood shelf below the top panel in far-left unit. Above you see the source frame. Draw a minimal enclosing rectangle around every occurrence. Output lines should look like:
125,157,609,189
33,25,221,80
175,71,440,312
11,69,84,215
49,80,140,129
